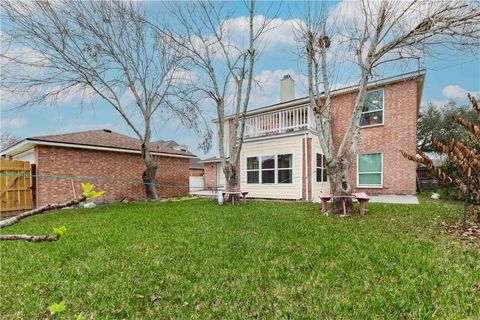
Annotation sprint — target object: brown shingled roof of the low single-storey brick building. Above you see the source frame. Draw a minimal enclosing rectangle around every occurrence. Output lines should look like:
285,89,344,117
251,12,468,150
1,129,194,158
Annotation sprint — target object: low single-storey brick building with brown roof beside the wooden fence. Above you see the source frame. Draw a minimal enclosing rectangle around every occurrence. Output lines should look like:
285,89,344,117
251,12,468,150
2,130,195,206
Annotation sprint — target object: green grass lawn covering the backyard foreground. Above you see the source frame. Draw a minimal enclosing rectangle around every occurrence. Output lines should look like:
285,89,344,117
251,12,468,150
0,199,480,319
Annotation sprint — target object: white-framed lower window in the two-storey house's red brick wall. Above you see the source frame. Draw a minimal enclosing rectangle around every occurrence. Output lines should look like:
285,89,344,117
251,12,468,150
357,153,383,187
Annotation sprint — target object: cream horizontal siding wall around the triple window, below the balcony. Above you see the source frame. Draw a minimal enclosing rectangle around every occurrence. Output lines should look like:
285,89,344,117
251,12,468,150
240,135,304,199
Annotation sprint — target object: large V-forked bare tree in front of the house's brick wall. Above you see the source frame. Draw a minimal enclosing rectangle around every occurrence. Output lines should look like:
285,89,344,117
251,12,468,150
296,0,480,209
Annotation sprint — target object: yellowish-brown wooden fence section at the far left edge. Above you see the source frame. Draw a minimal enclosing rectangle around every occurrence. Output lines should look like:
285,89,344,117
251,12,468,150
0,160,32,215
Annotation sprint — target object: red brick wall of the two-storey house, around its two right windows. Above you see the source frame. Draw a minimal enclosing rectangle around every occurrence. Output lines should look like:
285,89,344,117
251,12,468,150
332,80,418,195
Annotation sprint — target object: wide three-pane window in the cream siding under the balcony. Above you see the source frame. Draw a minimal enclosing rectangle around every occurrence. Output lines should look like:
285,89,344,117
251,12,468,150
247,154,293,184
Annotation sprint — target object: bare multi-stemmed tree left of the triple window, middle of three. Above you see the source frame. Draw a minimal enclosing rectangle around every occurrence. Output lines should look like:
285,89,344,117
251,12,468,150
169,0,273,202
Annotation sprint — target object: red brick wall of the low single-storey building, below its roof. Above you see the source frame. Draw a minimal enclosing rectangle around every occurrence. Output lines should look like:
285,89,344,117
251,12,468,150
35,146,189,206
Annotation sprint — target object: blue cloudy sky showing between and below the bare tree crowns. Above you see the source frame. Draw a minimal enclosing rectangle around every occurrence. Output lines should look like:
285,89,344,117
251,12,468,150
0,2,480,158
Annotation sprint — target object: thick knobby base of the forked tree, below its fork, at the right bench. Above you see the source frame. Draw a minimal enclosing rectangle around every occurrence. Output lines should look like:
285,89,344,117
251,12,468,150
327,159,353,214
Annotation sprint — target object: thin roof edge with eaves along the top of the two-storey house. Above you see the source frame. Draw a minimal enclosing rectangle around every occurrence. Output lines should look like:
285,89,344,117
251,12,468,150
219,70,425,122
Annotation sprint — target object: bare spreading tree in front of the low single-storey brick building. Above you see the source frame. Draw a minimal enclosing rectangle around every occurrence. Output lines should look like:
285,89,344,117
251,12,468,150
1,0,210,199
